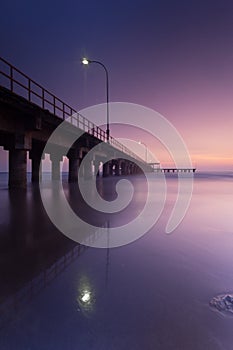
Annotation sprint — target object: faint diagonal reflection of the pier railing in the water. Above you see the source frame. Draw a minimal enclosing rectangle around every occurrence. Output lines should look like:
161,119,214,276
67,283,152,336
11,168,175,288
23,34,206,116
0,224,106,330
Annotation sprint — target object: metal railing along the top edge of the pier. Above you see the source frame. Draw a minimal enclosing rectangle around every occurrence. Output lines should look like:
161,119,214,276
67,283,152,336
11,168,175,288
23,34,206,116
0,57,146,164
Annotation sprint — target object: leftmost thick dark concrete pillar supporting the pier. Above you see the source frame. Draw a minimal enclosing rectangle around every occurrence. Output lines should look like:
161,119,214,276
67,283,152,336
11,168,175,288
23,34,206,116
8,149,27,189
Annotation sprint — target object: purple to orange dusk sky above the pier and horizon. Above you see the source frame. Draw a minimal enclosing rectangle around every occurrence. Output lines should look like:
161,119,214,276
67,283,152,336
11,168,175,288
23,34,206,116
0,0,233,170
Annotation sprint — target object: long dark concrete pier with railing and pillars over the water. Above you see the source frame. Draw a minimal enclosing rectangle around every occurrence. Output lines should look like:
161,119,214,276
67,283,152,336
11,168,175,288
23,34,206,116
0,58,153,188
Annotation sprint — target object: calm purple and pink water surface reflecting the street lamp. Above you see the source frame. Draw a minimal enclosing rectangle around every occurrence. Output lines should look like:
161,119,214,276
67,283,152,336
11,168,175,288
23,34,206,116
0,173,233,350
